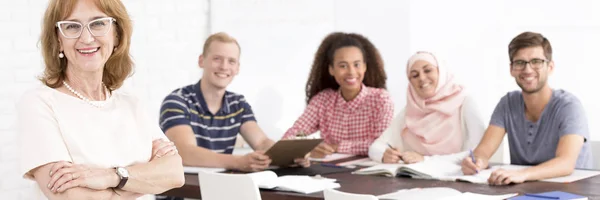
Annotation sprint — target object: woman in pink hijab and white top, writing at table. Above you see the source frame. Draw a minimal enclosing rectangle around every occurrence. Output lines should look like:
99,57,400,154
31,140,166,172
369,52,485,163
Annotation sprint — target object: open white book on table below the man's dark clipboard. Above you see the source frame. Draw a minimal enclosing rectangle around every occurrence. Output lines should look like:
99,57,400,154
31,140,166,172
248,171,340,194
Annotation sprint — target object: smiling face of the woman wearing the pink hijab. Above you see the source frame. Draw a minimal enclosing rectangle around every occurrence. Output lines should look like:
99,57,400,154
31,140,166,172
408,60,439,99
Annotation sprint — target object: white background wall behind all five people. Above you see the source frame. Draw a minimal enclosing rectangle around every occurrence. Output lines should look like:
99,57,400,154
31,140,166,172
0,0,600,199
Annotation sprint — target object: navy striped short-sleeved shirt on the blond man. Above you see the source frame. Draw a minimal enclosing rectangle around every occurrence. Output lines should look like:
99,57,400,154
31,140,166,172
159,82,256,154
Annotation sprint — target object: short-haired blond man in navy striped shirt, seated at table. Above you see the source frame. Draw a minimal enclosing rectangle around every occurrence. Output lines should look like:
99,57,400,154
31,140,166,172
160,32,308,188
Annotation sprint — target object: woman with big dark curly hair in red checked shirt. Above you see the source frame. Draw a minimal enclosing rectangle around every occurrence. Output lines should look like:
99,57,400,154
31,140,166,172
283,32,394,158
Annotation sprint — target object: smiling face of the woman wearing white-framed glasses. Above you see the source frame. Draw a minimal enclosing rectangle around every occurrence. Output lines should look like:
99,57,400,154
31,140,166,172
56,0,118,72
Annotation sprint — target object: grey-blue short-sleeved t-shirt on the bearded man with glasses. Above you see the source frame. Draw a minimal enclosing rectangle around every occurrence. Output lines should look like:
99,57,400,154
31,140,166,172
490,90,592,169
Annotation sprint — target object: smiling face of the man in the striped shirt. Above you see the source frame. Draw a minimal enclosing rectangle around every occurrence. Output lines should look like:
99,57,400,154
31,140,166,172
198,41,240,89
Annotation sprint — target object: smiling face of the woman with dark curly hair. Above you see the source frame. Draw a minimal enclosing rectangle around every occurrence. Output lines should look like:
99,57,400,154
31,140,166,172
329,46,367,92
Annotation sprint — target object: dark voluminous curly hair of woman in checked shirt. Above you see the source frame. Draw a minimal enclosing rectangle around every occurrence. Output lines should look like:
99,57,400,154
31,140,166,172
306,32,387,104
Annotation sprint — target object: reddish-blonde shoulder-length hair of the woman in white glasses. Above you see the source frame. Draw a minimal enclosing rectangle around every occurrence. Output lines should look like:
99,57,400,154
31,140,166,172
40,0,133,91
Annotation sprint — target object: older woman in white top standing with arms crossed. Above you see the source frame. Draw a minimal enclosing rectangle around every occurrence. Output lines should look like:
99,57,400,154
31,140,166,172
17,0,184,199
